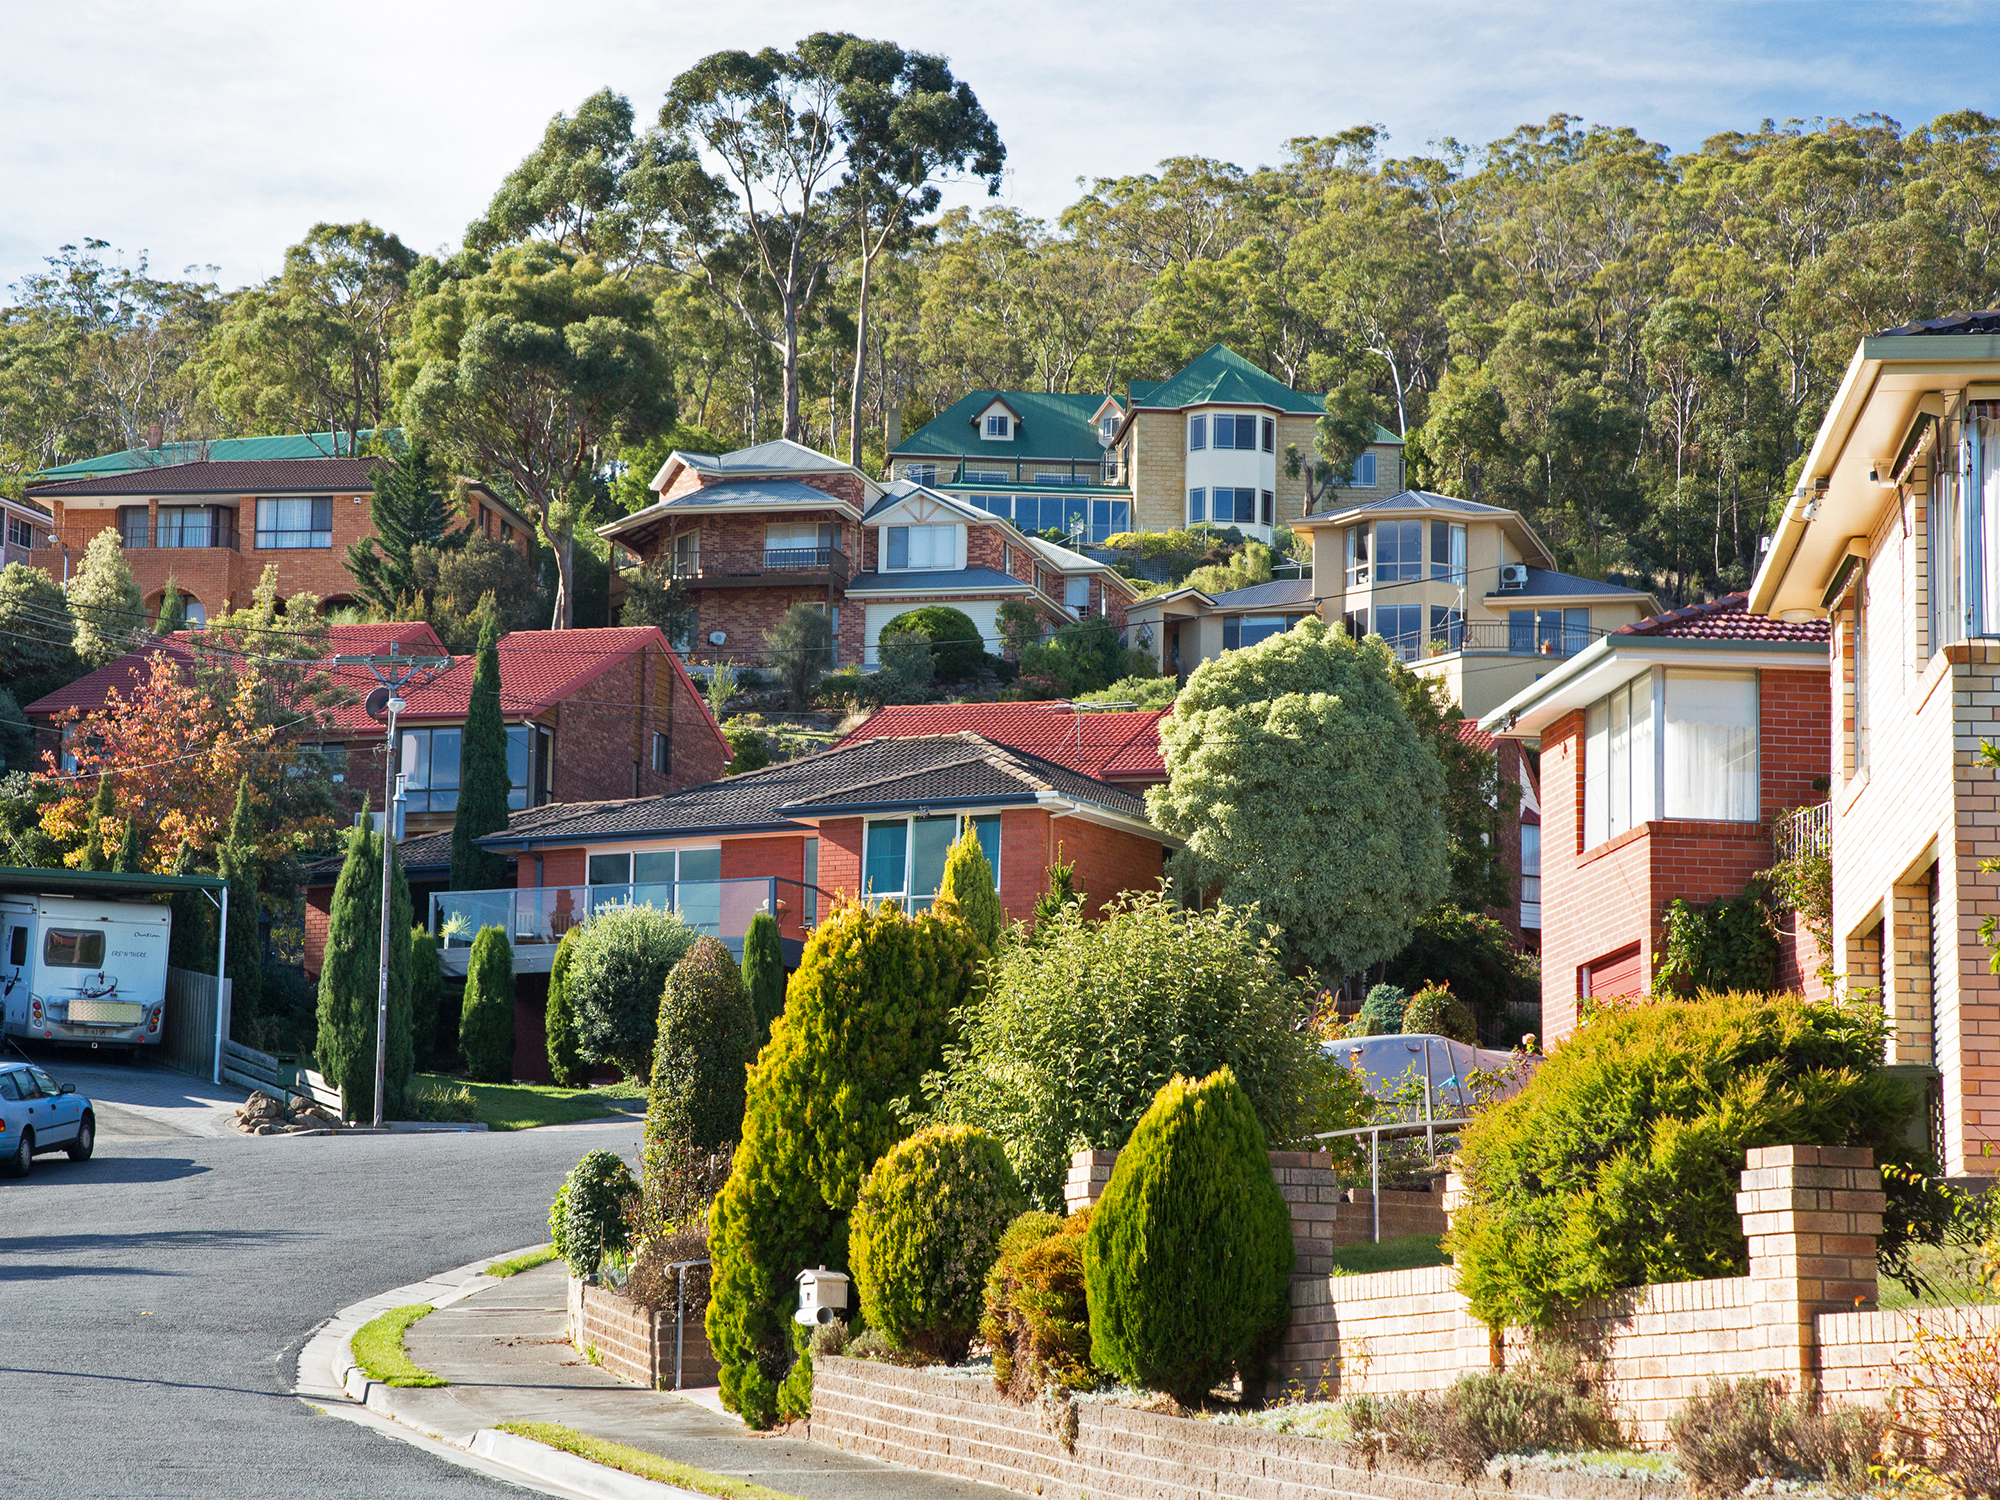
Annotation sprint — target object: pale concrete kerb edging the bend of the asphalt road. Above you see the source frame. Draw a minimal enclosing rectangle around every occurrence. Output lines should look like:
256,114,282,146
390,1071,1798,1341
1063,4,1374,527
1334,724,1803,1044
292,1240,708,1500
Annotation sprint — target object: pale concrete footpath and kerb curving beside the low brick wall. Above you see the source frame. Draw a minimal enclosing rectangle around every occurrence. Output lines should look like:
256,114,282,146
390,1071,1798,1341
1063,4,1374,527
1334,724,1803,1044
296,1262,1010,1500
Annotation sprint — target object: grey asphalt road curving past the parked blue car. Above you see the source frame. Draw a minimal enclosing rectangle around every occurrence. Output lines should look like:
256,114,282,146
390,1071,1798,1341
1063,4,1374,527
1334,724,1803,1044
0,1056,638,1500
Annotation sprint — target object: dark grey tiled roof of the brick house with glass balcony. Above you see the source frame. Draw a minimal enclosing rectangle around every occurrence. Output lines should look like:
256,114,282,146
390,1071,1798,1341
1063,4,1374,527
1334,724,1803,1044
480,734,1146,848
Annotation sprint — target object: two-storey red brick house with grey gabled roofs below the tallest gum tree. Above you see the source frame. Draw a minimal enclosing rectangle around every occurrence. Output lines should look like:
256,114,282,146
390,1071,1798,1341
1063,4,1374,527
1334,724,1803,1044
598,438,1136,664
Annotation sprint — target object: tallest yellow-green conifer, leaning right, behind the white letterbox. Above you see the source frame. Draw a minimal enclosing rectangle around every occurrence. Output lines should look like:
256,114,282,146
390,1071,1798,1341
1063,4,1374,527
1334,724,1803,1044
706,902,976,1428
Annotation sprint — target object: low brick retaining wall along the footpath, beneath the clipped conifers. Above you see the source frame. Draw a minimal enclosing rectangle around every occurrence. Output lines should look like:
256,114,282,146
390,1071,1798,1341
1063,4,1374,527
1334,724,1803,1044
808,1356,1684,1500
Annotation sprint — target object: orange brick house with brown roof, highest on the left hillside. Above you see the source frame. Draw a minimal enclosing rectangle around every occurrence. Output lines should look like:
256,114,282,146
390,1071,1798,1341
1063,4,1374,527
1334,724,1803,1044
28,456,534,624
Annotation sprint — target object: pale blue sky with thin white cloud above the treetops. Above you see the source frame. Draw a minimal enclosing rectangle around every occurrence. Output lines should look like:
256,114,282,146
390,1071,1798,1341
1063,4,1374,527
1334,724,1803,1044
0,0,2000,300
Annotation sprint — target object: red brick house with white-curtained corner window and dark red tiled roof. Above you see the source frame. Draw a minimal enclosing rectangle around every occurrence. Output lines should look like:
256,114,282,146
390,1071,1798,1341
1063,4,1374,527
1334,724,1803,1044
1480,594,1832,1040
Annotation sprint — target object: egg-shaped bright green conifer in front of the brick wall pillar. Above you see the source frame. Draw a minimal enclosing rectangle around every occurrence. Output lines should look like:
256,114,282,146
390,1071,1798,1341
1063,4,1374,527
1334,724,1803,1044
1084,1068,1292,1406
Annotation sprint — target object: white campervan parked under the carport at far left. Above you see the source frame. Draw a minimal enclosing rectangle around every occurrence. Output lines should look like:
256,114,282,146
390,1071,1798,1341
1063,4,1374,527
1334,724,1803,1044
0,894,174,1046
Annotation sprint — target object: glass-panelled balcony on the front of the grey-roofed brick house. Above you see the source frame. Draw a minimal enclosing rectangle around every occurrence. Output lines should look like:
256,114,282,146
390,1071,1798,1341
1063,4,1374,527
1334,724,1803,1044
430,876,820,974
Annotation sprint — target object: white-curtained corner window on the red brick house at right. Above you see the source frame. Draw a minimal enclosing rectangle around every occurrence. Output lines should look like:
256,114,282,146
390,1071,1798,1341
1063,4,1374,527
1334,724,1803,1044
1584,666,1760,848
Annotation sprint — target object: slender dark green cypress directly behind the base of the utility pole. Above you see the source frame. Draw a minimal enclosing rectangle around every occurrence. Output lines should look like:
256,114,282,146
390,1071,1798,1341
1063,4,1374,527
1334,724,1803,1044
316,822,412,1120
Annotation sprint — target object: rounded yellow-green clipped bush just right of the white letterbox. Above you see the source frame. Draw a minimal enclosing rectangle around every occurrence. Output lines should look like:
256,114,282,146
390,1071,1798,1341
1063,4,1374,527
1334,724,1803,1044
848,1126,1022,1364
